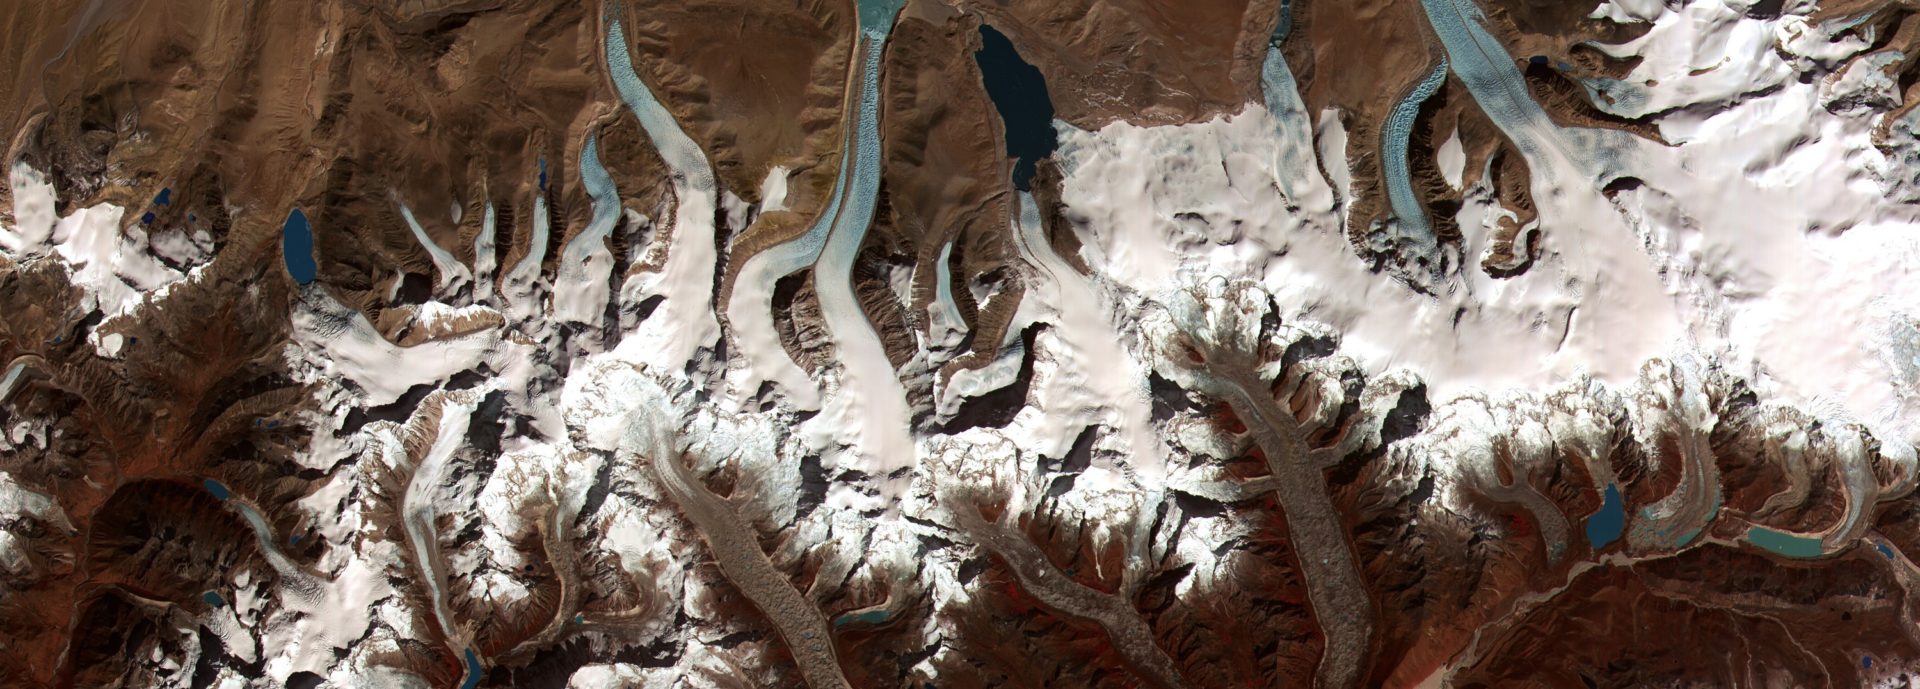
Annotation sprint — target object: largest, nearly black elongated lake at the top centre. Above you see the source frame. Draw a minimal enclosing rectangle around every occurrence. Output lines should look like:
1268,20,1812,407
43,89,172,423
973,25,1060,192
